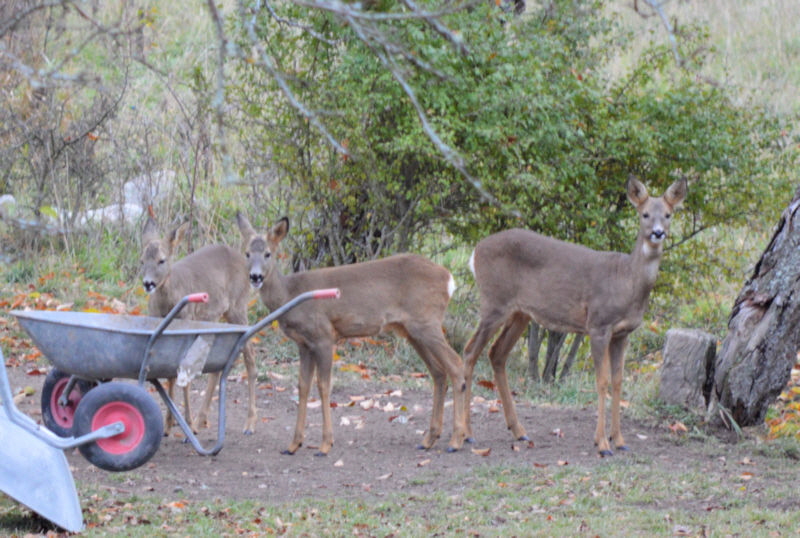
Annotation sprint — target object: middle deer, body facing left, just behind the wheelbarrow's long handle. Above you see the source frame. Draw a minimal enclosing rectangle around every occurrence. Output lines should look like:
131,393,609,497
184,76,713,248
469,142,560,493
236,212,466,456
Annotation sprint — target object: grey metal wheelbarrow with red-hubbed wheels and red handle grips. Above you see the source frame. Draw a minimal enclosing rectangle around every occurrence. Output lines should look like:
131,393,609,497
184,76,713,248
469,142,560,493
11,289,339,471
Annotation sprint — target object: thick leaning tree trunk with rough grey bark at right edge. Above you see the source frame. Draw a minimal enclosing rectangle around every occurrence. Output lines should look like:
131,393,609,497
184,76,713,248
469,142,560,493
709,189,800,426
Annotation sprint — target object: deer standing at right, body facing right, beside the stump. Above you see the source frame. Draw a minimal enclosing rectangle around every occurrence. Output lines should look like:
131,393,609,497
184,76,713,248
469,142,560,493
463,175,687,457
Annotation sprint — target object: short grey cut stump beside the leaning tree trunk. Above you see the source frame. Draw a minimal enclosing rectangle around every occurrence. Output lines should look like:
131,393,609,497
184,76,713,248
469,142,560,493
659,329,717,413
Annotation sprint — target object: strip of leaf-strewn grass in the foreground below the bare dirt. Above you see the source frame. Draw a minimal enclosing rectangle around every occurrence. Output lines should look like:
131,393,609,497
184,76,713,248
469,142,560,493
0,434,800,537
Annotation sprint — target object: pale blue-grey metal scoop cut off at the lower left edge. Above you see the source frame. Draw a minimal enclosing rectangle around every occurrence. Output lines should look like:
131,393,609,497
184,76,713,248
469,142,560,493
0,352,83,532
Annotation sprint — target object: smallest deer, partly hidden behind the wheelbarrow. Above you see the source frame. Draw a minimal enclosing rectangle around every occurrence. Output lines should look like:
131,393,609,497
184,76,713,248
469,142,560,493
141,216,257,435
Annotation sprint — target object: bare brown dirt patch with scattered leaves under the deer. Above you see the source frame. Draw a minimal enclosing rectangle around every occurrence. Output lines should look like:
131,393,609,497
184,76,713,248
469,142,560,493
7,356,768,502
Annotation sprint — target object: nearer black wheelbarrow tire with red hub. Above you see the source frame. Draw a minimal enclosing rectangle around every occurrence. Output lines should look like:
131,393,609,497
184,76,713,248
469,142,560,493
75,381,164,472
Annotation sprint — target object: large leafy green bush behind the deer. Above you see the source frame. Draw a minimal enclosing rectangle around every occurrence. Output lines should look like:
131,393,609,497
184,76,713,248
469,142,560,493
228,0,786,286
